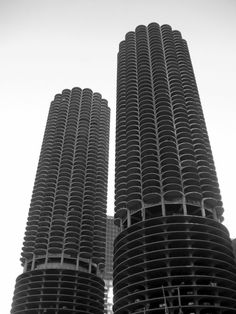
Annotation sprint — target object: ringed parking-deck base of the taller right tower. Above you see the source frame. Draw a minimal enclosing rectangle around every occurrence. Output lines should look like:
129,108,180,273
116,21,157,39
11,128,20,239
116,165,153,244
114,215,236,314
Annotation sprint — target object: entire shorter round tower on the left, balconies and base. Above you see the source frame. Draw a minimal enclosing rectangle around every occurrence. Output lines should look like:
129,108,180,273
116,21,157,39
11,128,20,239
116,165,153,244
11,88,110,314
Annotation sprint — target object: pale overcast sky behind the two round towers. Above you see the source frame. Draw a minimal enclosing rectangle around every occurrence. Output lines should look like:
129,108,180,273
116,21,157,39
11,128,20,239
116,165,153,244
0,0,236,314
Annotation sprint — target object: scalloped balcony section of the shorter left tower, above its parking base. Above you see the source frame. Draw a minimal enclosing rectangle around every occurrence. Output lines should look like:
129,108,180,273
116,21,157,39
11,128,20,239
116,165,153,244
22,88,109,270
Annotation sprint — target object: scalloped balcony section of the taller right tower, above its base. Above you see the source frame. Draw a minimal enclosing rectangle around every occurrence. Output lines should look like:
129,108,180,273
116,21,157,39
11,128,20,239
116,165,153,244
115,23,223,225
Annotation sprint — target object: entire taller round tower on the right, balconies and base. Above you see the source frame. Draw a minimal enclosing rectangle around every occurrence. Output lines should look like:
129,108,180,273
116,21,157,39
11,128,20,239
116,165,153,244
114,23,236,314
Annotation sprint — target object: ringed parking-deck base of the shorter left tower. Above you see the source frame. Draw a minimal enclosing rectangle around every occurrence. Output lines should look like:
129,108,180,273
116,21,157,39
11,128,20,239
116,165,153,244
11,269,104,314
